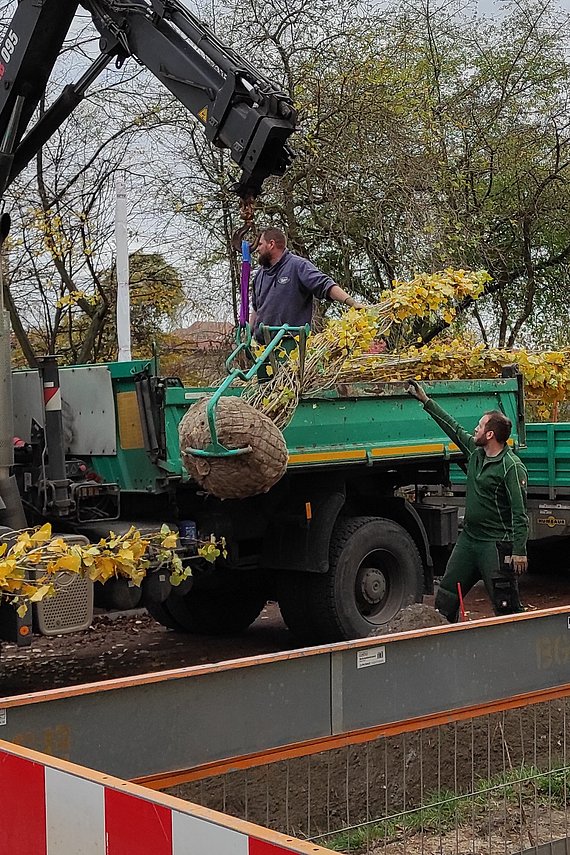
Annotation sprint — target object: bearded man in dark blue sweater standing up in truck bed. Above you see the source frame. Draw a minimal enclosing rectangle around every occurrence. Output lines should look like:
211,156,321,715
250,228,363,344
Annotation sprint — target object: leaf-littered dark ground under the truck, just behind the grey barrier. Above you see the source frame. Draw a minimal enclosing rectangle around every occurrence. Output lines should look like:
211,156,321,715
0,569,570,697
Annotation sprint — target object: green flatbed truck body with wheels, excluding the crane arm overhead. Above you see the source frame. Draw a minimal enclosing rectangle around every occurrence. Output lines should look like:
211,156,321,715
13,360,534,643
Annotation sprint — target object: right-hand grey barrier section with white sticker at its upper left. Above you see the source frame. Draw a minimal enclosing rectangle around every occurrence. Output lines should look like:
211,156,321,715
332,614,570,733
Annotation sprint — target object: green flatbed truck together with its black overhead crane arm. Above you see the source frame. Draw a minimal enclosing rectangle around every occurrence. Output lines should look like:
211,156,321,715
0,0,562,641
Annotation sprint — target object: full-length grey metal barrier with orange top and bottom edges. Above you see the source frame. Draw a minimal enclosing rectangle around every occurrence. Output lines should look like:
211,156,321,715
0,608,570,784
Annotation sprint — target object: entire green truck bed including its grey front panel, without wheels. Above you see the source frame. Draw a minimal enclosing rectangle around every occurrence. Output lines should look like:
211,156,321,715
14,360,524,493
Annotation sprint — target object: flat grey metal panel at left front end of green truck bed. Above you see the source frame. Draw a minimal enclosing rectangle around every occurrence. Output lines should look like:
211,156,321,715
12,365,117,455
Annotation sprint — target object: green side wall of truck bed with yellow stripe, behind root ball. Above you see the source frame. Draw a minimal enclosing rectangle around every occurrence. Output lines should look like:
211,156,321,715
159,378,519,474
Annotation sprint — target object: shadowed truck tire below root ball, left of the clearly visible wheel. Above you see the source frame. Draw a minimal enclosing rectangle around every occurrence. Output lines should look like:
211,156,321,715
163,590,267,635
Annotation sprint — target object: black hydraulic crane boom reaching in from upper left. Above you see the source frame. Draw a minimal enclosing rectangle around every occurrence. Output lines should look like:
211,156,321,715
0,0,296,198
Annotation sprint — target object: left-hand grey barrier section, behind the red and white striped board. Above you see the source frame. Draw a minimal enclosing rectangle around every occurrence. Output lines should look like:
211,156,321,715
0,656,330,778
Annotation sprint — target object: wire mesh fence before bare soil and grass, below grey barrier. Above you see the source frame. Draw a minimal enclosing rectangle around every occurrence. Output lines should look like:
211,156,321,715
165,687,570,855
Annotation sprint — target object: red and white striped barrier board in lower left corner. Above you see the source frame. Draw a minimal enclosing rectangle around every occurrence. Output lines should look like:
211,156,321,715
0,740,329,855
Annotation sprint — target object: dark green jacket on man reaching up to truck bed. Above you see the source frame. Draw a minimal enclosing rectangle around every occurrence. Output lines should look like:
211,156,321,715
424,398,528,555
